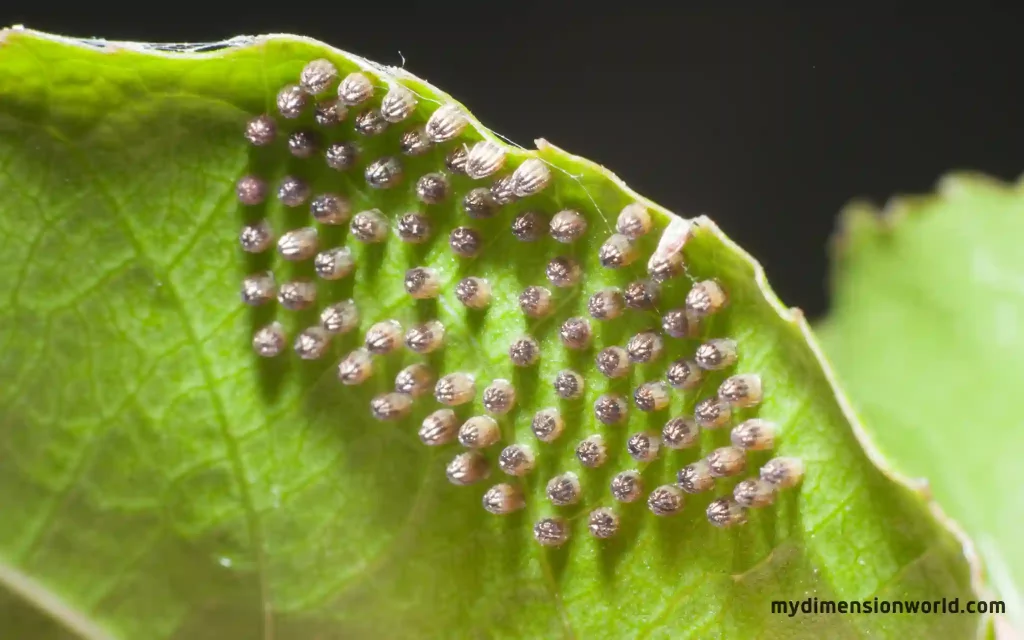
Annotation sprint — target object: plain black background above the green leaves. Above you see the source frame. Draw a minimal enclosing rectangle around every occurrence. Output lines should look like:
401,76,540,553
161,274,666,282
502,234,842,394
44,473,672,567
0,8,1024,317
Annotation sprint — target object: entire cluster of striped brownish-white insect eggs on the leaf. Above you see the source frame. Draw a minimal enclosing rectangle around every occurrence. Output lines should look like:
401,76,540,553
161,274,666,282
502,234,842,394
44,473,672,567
237,56,802,546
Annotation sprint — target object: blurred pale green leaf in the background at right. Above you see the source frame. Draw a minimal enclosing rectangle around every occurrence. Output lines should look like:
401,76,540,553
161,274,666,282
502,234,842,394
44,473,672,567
821,175,1024,628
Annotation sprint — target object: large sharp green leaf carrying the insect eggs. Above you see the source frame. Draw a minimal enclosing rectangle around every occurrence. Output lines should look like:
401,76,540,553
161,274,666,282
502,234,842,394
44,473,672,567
0,31,983,639
